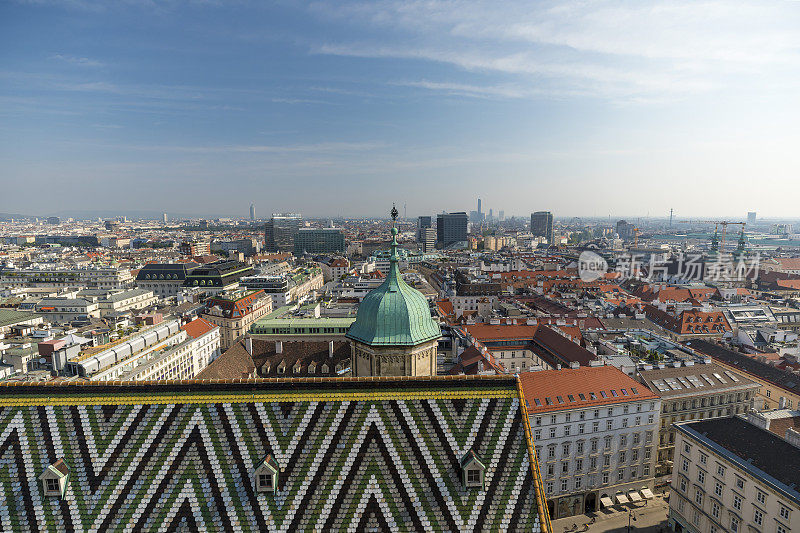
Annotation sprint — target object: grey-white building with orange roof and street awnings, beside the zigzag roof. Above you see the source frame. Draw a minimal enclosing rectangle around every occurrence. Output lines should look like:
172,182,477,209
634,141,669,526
519,366,661,519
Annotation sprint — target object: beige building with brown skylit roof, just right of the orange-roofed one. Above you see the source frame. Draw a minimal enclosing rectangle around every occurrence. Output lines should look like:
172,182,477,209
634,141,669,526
639,362,759,477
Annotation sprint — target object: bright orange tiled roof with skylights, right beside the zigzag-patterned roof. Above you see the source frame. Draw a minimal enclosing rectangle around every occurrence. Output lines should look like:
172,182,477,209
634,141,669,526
519,366,658,413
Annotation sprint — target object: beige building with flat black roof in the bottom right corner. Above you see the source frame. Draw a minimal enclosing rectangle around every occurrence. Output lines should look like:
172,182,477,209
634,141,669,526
669,416,800,533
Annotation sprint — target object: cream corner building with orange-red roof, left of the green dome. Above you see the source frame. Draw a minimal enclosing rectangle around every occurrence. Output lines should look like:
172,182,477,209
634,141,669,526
202,289,272,351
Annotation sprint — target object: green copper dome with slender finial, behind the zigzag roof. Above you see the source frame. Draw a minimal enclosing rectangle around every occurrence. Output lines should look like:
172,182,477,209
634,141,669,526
347,223,442,346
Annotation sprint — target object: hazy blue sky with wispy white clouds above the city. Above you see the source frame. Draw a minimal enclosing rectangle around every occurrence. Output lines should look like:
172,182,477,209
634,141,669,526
0,0,800,219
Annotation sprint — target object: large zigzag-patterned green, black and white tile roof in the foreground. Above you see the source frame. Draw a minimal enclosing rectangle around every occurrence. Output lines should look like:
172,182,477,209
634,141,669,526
0,376,551,532
